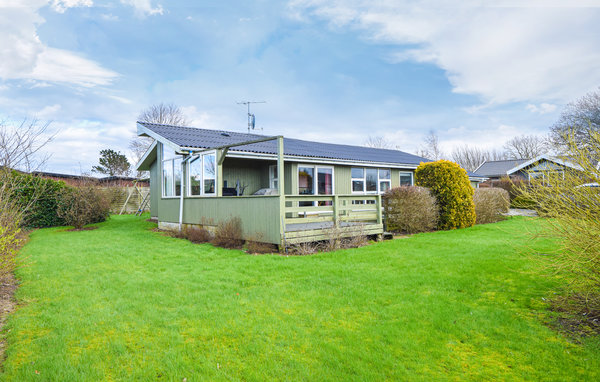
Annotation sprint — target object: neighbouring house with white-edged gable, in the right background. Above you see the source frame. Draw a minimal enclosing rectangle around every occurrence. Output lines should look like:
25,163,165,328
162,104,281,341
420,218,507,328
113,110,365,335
475,155,581,180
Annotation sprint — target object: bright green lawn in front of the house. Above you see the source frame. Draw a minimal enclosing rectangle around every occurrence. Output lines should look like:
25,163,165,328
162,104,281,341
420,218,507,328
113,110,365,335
2,216,600,381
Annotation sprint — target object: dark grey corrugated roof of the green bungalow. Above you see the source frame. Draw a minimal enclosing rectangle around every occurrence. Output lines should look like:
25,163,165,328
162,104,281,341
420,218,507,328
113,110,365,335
138,122,430,165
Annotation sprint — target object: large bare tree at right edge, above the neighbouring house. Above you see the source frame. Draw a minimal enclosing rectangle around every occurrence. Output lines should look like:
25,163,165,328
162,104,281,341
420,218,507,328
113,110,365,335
550,88,600,152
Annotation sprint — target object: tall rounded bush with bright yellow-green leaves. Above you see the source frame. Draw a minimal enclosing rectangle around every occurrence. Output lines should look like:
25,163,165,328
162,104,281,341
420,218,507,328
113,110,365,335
415,160,475,229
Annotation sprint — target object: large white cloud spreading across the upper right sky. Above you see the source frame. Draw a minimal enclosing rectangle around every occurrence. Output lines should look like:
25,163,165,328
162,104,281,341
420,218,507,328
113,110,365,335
290,0,600,103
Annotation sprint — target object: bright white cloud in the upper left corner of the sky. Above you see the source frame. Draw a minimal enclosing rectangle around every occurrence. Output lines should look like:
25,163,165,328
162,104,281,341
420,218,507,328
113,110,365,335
0,0,117,87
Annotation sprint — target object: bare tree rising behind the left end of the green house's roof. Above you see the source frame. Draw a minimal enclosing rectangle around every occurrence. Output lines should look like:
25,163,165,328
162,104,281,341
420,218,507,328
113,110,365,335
129,102,191,163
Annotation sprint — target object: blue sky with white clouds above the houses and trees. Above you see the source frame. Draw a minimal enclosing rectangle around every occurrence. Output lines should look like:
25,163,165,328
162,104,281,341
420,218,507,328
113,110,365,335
0,0,600,174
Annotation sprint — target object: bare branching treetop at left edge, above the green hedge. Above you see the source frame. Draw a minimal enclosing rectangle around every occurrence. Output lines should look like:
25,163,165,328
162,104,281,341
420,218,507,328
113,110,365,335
0,118,54,172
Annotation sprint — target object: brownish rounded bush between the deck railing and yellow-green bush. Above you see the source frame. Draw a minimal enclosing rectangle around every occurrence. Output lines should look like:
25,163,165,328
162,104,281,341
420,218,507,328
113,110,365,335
382,186,439,233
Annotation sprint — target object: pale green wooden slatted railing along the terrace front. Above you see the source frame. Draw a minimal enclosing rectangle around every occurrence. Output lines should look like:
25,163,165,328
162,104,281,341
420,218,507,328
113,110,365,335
285,195,382,225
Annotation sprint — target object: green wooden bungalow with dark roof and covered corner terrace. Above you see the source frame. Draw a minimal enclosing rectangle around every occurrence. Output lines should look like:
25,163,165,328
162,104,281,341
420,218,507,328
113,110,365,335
137,122,484,246
